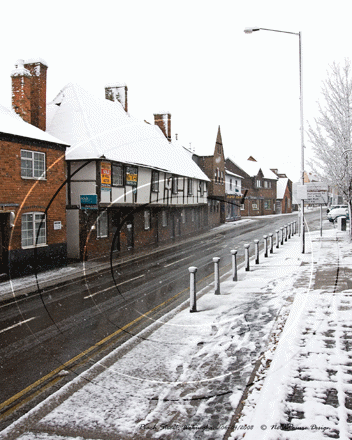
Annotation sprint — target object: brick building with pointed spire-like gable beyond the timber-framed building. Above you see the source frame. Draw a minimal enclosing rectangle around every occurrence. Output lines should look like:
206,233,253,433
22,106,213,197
193,126,226,226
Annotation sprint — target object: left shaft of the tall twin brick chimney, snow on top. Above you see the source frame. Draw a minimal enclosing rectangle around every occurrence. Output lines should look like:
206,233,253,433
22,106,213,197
11,60,32,124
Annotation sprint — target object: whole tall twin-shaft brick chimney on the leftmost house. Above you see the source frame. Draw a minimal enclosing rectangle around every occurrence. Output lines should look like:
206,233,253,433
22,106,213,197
11,59,48,131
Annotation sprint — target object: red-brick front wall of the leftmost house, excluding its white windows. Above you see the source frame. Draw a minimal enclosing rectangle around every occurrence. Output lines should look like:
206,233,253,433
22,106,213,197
0,139,66,275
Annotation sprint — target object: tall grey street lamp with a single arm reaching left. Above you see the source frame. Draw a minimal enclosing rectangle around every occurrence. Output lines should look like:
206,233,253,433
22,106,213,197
244,27,305,254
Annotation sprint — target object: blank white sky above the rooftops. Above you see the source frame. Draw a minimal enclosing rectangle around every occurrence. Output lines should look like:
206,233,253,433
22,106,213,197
0,0,352,181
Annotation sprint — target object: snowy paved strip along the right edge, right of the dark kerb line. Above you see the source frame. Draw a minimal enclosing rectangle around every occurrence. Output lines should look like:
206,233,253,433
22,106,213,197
230,230,352,440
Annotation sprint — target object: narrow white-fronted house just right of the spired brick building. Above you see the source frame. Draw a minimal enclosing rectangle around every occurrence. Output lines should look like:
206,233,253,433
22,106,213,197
225,169,243,221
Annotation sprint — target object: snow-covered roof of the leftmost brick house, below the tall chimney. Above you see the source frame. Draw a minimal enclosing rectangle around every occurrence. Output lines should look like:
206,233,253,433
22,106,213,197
0,105,68,146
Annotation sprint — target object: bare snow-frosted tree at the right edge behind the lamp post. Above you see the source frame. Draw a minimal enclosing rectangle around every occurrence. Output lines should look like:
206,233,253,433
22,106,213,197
308,59,352,234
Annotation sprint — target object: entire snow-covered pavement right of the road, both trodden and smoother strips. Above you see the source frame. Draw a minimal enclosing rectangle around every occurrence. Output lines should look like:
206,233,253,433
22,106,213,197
0,225,352,440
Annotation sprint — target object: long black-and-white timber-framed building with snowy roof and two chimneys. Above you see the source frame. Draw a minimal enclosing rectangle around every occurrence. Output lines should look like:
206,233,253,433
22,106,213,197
47,84,209,260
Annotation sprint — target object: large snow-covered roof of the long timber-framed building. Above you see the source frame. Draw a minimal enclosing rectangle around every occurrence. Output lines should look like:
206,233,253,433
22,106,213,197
47,84,209,180
